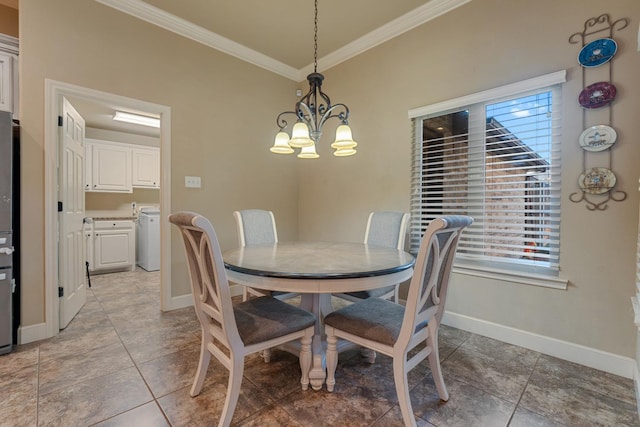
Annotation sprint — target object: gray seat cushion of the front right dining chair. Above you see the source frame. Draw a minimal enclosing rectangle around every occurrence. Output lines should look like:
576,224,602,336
324,298,404,346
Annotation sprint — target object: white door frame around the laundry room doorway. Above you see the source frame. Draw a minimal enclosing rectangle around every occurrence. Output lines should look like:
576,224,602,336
44,79,172,337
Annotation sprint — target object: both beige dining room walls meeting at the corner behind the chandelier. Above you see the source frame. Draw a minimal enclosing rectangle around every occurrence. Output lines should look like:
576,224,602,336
20,0,640,362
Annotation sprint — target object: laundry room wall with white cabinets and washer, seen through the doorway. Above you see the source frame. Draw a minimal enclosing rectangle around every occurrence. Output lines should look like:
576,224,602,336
76,112,160,275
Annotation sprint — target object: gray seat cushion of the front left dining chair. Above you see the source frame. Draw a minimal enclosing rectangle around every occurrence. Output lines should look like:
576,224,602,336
234,297,316,345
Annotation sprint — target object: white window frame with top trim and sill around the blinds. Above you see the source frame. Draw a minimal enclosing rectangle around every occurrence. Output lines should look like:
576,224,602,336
408,70,567,289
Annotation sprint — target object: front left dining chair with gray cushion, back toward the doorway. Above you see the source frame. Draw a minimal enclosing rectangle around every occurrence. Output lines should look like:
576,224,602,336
169,212,316,426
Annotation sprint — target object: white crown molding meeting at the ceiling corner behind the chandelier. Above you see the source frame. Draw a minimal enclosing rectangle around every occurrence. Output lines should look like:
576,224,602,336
95,0,471,82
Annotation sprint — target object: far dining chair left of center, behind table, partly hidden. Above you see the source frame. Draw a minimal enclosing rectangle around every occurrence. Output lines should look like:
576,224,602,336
233,209,298,301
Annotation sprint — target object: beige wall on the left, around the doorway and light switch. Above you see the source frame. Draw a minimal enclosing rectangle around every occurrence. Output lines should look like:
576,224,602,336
20,0,297,326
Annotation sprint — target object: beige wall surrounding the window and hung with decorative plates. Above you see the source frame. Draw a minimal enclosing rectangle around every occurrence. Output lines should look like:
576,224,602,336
299,0,640,357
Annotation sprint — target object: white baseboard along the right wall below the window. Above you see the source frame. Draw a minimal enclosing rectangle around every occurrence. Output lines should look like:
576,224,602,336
442,310,638,381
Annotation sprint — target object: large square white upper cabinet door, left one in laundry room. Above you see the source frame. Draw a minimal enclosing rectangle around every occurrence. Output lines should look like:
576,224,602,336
92,144,133,193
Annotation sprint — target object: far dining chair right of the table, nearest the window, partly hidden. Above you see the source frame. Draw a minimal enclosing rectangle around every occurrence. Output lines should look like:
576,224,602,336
333,211,411,302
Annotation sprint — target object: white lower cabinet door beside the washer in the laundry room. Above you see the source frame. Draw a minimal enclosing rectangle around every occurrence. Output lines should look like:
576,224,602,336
93,229,135,270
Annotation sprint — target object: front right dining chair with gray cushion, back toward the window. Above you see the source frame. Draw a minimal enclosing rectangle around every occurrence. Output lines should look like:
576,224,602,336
324,215,473,426
